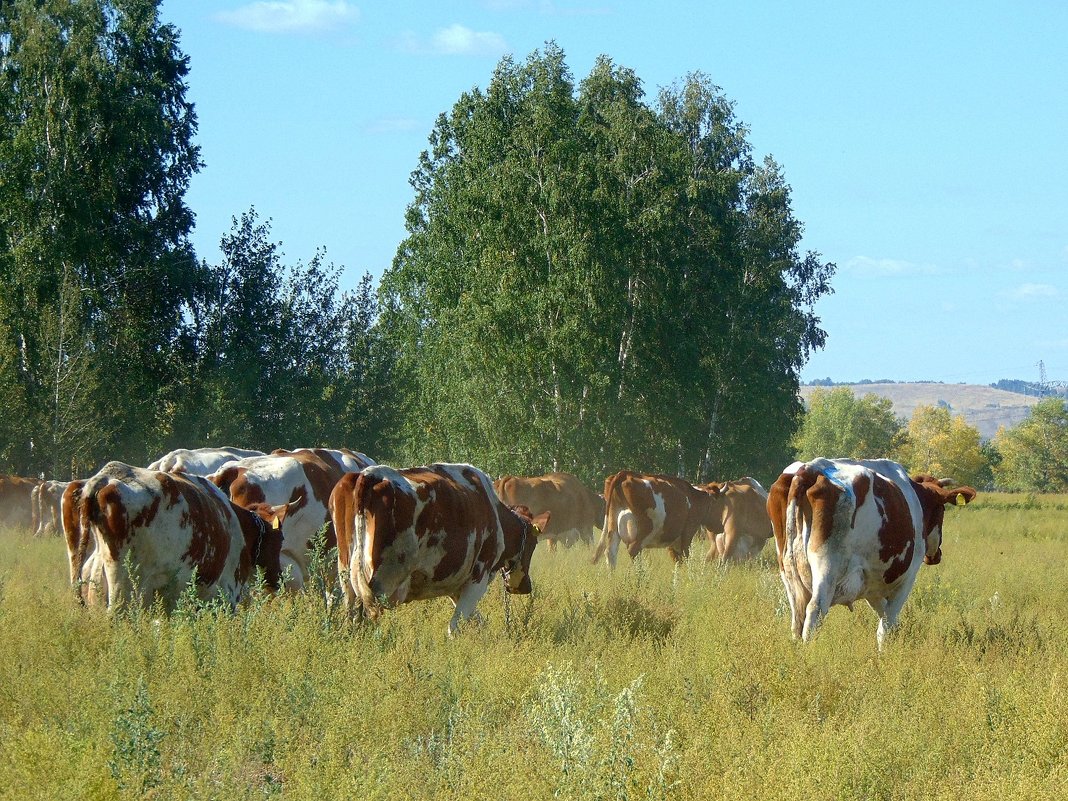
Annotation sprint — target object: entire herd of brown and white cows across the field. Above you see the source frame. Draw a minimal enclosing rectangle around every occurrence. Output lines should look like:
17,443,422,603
0,447,975,647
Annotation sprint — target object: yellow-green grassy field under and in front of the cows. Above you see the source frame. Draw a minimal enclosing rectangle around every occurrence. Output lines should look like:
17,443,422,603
0,494,1068,801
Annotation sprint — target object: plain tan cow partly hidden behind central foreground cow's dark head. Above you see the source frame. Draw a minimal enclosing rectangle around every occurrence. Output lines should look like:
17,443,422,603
493,473,604,550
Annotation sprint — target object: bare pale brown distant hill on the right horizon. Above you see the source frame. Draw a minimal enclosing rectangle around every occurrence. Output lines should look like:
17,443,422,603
801,381,1039,440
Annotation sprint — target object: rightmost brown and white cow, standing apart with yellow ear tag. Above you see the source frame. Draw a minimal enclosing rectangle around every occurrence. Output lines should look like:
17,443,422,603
768,458,975,648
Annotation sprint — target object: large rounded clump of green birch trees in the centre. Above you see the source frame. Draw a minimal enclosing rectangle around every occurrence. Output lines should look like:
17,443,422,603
381,45,833,480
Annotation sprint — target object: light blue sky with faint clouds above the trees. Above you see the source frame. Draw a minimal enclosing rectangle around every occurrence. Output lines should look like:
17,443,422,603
161,0,1068,383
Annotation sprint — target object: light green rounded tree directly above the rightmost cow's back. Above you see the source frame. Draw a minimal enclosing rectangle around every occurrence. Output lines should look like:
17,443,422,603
791,387,901,461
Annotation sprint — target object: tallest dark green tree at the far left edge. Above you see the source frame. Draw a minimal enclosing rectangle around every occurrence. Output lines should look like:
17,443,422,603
0,0,202,475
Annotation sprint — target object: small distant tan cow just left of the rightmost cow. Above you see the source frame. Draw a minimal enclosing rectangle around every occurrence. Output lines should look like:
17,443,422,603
698,476,771,562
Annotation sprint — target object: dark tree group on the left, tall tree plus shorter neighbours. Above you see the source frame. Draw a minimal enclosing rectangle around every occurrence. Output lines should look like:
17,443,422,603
0,0,394,477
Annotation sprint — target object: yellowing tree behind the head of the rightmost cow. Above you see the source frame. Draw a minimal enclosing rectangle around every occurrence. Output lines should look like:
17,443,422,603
895,406,992,487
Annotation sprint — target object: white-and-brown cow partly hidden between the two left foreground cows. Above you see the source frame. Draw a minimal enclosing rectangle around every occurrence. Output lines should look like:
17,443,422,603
208,447,370,591
